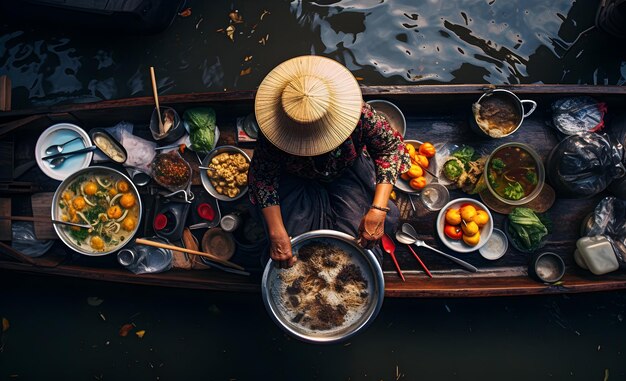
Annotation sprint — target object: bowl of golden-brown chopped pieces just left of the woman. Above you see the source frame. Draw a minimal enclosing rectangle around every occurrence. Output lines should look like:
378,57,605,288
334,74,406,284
200,146,250,201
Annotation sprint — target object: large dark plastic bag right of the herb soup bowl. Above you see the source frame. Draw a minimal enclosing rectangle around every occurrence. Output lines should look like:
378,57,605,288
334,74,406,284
546,133,626,198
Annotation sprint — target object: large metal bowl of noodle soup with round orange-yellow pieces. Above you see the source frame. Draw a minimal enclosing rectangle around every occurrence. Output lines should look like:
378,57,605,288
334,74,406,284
51,167,142,256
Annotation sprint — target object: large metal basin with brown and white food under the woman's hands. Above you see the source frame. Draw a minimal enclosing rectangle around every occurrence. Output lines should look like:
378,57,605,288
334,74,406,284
261,230,385,343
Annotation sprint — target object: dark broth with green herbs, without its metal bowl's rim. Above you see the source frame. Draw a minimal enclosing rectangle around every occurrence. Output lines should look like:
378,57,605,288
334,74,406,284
487,146,538,201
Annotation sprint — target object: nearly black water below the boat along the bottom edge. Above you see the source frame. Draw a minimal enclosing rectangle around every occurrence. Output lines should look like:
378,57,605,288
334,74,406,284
0,272,626,380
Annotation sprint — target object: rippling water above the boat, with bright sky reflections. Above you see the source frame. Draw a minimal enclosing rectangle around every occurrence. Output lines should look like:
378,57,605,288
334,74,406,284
0,0,626,108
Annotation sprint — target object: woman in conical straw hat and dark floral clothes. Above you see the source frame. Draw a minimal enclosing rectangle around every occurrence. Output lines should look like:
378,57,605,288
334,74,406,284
248,56,410,267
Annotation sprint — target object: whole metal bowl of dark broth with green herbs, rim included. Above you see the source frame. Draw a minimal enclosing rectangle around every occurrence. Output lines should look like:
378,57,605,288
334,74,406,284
484,143,545,205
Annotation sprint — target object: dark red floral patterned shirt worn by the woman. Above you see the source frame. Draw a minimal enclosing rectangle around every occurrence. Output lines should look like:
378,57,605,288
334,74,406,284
248,103,411,208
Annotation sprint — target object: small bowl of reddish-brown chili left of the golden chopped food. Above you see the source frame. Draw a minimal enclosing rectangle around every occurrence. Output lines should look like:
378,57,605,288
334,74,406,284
152,151,191,192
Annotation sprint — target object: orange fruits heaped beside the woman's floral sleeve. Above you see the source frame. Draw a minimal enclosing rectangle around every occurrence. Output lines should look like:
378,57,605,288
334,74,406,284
396,140,437,193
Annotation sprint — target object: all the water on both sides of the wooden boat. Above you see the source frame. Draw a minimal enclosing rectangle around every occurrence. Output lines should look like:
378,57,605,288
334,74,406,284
0,0,626,381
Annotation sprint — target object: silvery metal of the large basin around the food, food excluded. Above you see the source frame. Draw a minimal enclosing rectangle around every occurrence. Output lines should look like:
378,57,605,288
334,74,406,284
261,230,385,343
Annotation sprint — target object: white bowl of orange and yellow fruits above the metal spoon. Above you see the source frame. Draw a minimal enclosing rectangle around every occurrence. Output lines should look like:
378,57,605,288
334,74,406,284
437,198,493,253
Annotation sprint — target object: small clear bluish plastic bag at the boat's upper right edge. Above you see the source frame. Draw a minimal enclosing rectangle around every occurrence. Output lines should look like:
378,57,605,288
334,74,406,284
552,96,607,135
